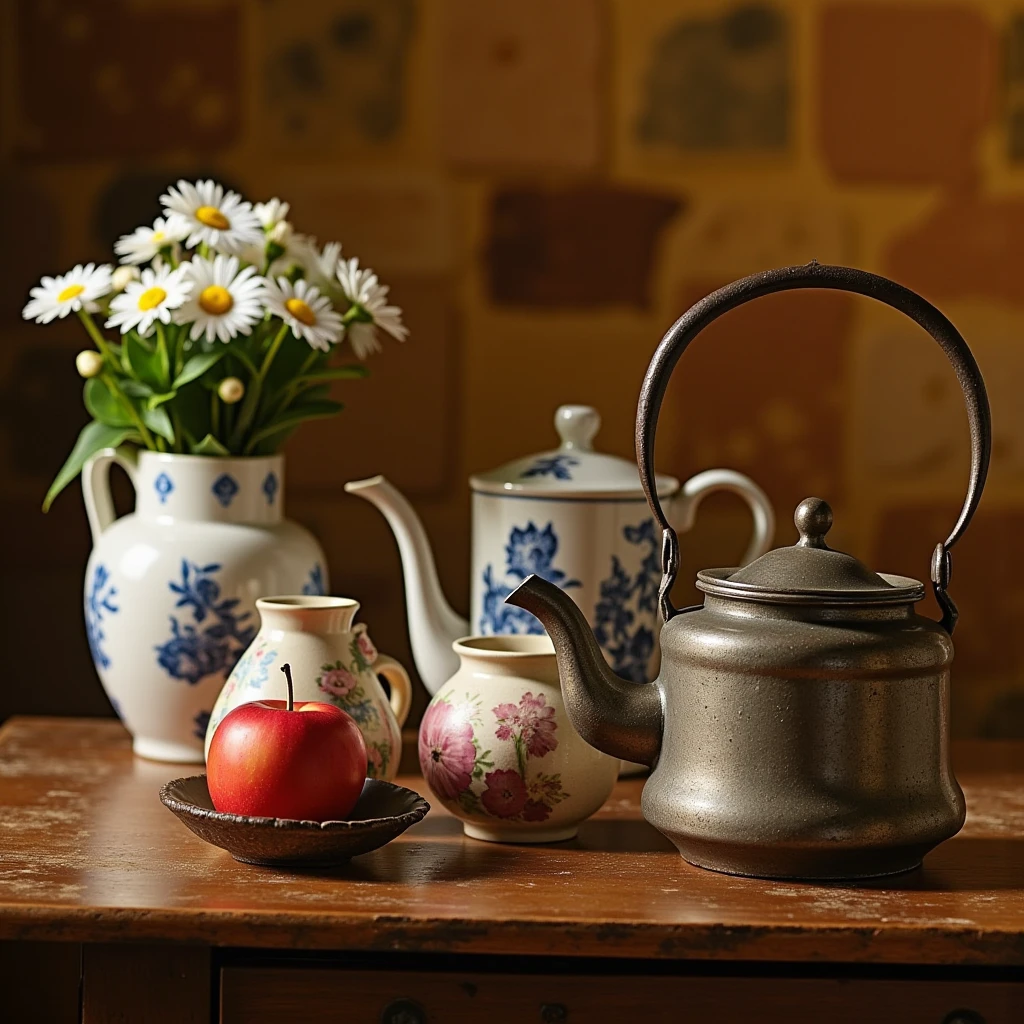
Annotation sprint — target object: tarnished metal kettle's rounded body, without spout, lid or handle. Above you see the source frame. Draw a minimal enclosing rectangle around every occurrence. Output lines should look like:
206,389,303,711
643,557,967,879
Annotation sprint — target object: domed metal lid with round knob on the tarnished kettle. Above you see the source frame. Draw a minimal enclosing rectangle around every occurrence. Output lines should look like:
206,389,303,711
697,498,925,604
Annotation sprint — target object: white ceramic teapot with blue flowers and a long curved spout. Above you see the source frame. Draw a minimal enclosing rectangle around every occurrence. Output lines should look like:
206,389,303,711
345,406,775,695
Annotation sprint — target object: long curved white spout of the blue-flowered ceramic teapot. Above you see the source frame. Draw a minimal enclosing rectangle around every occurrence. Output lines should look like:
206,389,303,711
345,476,469,695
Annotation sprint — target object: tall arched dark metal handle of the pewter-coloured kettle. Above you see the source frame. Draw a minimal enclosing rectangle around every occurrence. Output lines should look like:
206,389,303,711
636,261,992,633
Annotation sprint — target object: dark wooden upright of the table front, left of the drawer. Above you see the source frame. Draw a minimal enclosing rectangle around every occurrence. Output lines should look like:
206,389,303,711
82,945,212,1024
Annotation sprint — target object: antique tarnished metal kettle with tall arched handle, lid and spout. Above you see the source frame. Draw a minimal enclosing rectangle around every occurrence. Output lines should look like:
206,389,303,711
508,263,991,879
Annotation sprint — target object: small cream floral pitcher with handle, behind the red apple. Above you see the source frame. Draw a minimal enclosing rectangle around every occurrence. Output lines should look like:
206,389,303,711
206,596,413,781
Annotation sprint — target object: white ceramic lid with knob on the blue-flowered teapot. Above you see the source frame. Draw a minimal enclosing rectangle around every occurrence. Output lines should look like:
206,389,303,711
469,406,679,500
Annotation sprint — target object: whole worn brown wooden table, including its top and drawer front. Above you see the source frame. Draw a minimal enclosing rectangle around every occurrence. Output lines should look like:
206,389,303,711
0,719,1024,1024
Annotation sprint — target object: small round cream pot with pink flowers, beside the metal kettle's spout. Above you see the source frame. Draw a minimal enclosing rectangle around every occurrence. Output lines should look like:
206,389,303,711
419,635,618,843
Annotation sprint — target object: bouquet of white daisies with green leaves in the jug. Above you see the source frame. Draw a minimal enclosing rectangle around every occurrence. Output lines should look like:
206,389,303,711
23,181,407,509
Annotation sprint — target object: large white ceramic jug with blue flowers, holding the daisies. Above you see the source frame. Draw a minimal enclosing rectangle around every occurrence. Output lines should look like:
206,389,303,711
82,449,327,763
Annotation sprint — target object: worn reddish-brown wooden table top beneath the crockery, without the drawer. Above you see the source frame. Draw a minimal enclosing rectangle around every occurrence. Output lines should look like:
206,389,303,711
0,718,1024,965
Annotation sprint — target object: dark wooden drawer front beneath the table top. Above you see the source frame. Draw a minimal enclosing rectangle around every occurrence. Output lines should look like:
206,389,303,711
221,968,1024,1024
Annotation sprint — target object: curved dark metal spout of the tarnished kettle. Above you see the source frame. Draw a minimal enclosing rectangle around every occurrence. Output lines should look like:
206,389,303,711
505,575,663,767
